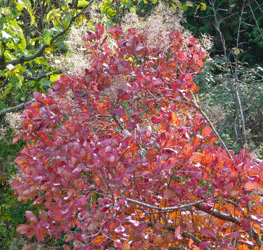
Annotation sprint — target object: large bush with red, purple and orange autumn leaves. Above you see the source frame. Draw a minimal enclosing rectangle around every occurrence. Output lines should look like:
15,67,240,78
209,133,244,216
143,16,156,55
12,24,263,250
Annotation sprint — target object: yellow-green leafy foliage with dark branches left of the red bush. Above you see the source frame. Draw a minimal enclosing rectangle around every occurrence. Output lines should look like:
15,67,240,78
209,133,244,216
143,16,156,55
0,0,189,249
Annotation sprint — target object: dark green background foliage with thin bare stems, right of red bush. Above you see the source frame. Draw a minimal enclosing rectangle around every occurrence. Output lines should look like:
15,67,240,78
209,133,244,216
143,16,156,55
179,0,263,152
